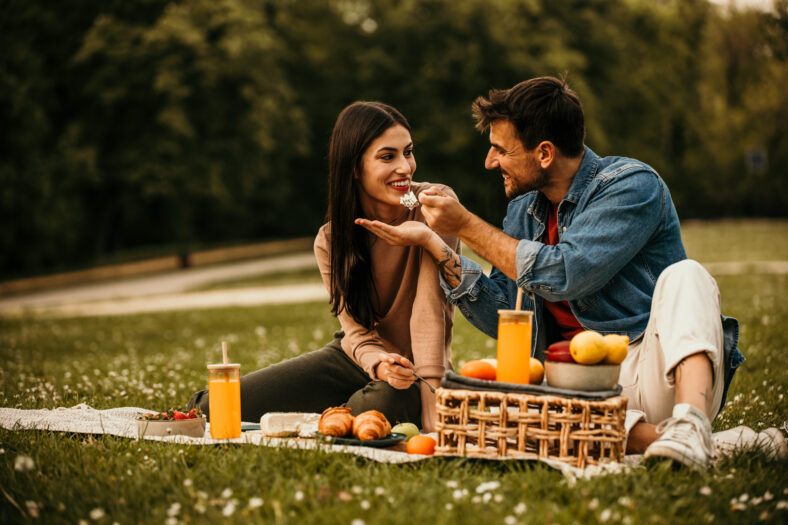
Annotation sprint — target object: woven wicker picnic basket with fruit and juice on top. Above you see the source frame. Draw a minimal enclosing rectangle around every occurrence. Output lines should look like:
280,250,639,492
435,388,627,468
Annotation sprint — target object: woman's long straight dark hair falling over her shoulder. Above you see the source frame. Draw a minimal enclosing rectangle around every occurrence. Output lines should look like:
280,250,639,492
326,102,410,330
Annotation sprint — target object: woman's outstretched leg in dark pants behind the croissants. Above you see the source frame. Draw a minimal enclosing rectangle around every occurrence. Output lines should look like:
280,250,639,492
189,338,372,421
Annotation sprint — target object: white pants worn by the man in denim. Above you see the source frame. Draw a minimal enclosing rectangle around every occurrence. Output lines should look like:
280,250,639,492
619,260,724,432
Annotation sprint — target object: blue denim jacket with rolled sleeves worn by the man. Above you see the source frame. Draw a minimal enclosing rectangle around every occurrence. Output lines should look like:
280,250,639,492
441,147,744,405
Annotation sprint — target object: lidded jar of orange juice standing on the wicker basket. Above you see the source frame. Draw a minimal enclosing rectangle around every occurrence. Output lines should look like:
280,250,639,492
496,310,533,385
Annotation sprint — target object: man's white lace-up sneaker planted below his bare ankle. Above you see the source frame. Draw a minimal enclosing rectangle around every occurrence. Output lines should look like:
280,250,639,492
643,403,714,470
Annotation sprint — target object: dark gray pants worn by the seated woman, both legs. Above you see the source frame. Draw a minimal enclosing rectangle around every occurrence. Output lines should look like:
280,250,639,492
188,332,421,427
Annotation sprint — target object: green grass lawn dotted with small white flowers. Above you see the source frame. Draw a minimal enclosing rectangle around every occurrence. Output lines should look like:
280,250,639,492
0,219,788,525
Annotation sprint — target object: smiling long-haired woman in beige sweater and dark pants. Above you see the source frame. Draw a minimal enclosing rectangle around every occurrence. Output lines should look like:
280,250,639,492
189,102,459,431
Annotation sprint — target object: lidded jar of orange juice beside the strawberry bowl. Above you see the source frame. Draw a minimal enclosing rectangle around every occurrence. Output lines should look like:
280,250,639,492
208,364,241,439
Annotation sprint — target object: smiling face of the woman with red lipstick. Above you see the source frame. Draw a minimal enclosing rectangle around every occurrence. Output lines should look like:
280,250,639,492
357,124,416,219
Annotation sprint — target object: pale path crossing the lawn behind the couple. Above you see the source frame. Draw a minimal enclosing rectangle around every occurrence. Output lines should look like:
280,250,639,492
0,253,788,317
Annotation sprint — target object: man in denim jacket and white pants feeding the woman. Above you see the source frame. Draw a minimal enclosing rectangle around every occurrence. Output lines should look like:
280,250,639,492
357,77,744,469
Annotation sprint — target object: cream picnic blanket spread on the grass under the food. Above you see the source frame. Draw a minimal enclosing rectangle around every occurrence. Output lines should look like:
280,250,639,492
0,403,640,481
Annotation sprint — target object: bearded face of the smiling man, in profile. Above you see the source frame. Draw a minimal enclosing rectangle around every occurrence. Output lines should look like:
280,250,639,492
484,120,550,200
